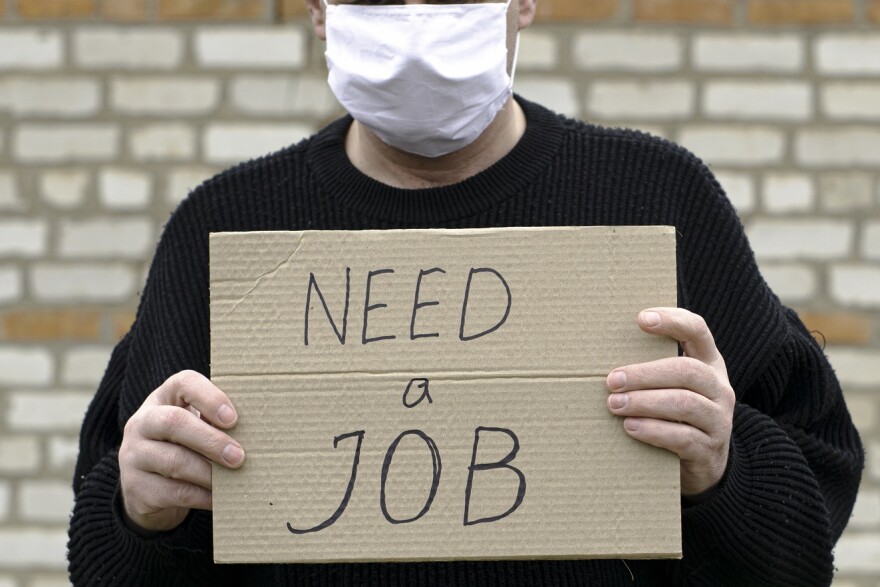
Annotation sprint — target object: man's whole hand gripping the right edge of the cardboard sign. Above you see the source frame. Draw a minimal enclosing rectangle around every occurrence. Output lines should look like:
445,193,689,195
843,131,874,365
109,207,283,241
607,308,736,497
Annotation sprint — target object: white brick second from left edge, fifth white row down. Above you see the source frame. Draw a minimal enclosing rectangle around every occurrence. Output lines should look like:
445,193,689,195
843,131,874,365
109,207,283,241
58,217,155,259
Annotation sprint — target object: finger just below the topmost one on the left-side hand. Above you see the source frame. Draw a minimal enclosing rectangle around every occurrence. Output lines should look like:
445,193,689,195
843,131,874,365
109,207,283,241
138,406,244,468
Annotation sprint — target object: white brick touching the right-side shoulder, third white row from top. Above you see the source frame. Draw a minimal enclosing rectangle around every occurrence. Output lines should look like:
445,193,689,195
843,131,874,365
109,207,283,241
678,126,785,166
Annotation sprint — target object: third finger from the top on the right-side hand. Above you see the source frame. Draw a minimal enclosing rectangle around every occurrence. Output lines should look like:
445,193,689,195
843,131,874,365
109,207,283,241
608,389,723,436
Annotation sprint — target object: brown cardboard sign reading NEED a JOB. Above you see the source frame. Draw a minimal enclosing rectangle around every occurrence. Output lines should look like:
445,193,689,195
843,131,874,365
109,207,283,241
210,226,681,563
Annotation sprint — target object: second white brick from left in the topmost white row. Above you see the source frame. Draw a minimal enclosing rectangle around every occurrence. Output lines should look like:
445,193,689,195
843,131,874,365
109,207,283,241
73,27,184,70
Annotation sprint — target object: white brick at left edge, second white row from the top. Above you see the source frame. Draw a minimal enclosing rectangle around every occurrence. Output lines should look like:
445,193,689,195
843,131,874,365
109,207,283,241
0,76,101,117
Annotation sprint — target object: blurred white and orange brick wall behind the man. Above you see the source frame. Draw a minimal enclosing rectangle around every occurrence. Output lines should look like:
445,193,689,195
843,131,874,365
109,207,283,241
0,0,880,587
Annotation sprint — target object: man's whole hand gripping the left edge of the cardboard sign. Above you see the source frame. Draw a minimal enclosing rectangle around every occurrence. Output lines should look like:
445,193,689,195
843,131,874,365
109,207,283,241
119,371,244,531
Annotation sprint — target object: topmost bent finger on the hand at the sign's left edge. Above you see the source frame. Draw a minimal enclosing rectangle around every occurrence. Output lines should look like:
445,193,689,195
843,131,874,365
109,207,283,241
148,371,238,428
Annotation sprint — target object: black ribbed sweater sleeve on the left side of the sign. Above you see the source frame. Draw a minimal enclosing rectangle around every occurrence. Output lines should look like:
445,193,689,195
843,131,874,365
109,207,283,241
68,194,242,586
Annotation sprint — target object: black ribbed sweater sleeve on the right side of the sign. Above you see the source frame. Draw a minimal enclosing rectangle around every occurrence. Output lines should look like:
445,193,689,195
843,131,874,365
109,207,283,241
677,165,864,587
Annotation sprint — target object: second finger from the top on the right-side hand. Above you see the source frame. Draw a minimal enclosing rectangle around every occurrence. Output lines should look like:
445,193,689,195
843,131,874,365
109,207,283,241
606,357,727,400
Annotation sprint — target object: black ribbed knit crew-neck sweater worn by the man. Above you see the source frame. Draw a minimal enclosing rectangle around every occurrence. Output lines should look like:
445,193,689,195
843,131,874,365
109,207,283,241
69,100,863,587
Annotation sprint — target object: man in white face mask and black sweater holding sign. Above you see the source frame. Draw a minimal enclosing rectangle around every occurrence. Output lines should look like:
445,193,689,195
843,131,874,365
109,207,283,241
70,0,863,586
